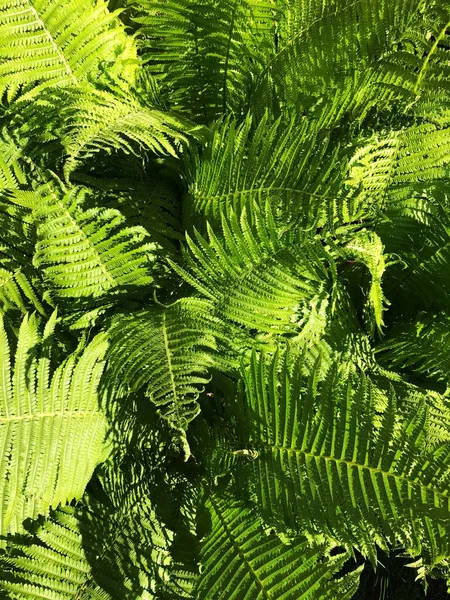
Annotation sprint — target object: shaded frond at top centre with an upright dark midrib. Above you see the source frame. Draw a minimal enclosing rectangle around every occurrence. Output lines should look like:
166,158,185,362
128,0,280,123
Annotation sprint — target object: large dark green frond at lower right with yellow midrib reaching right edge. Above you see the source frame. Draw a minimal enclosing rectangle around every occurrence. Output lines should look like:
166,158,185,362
244,354,450,563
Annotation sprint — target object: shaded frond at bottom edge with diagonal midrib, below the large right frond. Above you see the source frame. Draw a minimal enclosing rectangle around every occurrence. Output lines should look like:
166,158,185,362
197,493,361,600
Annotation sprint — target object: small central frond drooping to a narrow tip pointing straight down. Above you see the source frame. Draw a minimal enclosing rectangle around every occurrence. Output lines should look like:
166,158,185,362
108,298,219,452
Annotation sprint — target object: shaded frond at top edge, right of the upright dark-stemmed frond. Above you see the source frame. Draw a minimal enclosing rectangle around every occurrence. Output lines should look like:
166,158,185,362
255,0,425,120
